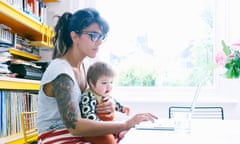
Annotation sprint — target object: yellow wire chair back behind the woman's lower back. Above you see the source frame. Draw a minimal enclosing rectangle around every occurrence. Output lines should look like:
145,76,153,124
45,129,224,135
21,111,38,144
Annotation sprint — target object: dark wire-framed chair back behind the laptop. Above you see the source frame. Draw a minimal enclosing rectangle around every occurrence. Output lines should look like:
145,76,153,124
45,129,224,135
168,106,224,120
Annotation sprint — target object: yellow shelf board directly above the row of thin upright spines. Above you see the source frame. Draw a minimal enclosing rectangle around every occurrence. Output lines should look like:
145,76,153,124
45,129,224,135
0,77,40,90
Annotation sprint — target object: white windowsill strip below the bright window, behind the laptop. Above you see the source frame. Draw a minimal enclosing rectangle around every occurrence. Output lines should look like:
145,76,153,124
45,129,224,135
113,87,240,105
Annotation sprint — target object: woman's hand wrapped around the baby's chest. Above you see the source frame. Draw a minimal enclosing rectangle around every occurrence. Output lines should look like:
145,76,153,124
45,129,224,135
96,97,115,117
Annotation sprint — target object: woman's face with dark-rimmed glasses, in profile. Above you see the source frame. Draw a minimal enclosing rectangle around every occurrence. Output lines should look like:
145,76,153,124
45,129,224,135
75,23,102,58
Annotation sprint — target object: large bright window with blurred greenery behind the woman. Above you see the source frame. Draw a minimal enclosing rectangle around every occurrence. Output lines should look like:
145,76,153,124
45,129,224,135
96,0,223,87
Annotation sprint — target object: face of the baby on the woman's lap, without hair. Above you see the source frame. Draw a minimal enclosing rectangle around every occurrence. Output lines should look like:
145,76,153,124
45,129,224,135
91,75,113,97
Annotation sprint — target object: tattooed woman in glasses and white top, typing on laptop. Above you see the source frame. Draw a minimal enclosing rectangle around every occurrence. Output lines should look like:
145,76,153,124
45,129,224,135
37,8,156,144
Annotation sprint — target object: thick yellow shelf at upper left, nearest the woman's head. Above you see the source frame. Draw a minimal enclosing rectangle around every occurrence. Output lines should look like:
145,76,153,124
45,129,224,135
0,0,54,48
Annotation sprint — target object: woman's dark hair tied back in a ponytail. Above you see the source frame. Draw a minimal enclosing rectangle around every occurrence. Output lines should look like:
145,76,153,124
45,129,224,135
53,8,109,59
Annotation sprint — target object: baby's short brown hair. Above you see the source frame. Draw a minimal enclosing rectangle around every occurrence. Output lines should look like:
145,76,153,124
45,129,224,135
87,62,115,85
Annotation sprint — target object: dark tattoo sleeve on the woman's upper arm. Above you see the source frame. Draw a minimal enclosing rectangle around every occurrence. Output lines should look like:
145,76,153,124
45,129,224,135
53,74,80,129
